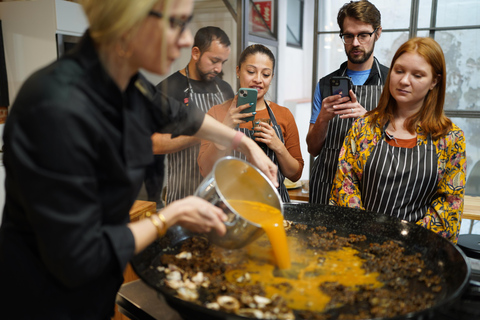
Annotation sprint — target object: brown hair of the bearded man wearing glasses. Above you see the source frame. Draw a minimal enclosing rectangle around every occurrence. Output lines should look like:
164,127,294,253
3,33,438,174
337,0,382,33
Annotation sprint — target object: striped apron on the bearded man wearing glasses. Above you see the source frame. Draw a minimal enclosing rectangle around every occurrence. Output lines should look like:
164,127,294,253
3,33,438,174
309,80,383,204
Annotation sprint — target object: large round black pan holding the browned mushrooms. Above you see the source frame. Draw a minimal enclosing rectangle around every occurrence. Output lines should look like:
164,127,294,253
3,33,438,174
132,203,470,320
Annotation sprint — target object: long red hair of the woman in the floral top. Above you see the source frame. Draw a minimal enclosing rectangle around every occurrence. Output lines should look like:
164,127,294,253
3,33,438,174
367,38,452,139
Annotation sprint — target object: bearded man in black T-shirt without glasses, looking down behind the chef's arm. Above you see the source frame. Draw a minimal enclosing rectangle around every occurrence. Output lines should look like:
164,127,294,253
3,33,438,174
145,26,234,207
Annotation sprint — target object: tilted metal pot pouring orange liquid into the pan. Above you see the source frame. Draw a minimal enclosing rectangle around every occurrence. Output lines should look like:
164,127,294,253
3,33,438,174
195,157,283,249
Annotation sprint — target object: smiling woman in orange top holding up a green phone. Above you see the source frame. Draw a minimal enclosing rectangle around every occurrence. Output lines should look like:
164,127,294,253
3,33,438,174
198,44,303,202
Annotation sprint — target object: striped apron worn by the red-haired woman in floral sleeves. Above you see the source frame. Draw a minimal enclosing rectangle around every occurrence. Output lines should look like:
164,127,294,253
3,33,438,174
360,123,438,221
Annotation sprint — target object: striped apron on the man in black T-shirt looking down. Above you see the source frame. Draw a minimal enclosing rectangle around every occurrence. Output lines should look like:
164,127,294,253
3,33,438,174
167,68,225,204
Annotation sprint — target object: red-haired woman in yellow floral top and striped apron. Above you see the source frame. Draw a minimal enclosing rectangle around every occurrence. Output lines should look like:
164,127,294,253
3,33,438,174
330,38,466,243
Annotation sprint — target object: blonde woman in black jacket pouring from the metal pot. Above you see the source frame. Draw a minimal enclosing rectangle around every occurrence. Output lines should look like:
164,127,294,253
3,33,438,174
0,0,276,320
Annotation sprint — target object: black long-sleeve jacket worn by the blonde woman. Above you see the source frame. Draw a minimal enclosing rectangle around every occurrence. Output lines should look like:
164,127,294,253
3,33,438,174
0,31,204,319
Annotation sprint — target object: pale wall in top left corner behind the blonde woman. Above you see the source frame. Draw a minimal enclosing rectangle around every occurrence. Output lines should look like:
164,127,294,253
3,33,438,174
0,0,88,105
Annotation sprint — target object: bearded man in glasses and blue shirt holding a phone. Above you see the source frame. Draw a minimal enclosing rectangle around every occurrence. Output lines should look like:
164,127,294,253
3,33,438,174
307,0,388,204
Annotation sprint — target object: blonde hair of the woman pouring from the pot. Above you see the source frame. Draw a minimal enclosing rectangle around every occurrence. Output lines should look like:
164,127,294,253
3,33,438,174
79,0,172,45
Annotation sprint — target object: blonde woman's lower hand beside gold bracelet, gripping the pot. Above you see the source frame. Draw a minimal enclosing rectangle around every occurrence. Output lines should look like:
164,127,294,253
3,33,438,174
161,196,227,236
